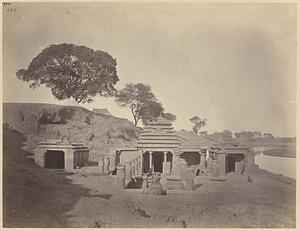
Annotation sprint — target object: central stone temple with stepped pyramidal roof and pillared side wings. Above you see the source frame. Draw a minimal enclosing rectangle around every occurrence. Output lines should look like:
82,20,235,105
110,117,254,175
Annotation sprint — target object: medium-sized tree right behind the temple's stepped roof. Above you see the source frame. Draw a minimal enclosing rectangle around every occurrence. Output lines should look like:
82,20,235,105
115,83,176,126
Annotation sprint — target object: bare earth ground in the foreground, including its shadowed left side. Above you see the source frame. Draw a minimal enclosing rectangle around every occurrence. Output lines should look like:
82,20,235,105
3,127,296,228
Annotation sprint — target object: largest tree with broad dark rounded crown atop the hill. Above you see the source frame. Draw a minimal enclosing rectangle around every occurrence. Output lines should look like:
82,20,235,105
16,43,119,103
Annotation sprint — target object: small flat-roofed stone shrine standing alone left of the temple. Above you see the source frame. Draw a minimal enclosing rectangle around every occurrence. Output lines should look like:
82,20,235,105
34,137,89,170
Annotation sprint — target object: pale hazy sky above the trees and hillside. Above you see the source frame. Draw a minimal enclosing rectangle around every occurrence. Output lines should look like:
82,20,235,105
3,3,297,136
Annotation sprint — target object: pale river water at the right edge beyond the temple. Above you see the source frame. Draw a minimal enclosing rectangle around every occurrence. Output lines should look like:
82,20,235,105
255,152,296,179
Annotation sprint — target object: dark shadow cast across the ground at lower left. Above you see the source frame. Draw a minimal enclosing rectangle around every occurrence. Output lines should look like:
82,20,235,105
3,126,88,228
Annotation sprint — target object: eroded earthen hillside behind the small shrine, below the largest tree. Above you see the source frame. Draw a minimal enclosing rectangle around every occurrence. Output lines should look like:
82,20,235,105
3,103,140,160
